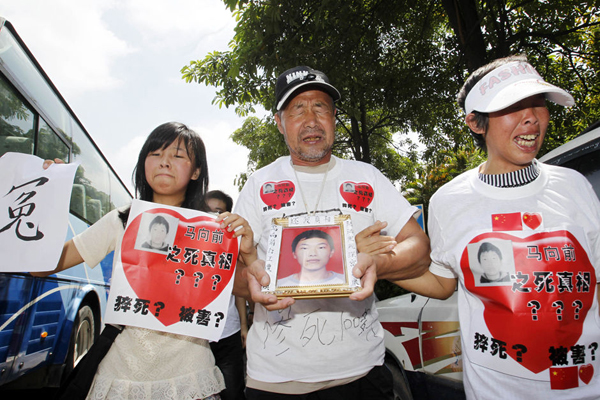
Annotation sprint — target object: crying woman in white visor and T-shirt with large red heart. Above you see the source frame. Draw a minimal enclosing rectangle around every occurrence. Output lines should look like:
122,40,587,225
398,56,600,400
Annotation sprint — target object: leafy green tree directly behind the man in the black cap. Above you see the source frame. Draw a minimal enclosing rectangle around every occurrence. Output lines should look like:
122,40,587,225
182,0,456,184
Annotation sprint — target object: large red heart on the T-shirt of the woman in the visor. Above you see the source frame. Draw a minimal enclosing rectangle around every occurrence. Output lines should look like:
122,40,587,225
461,231,596,374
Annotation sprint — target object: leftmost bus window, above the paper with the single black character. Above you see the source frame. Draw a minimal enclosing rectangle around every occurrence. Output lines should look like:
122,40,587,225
0,76,35,156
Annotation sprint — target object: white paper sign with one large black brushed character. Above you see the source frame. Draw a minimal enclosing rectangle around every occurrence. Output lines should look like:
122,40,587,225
0,153,79,272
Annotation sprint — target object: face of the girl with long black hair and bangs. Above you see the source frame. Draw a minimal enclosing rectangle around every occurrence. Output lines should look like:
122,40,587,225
144,140,200,206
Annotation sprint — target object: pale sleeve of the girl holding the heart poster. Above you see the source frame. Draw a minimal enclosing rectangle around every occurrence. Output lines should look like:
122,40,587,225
73,209,123,268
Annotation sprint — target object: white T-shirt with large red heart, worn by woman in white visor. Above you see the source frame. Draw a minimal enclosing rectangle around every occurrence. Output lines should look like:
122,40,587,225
428,163,600,400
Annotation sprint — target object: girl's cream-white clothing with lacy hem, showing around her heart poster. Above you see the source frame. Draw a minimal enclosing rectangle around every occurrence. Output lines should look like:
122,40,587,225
73,210,225,400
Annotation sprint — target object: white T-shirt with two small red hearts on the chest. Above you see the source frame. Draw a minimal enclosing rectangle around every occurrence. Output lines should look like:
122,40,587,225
235,156,416,382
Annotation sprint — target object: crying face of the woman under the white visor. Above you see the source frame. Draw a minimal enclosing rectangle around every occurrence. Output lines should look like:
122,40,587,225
483,95,550,174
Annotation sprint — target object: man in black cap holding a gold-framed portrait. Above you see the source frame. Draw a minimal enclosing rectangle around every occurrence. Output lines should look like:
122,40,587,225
236,67,429,400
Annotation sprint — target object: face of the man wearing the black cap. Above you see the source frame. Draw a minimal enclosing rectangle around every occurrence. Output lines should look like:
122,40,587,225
275,90,335,165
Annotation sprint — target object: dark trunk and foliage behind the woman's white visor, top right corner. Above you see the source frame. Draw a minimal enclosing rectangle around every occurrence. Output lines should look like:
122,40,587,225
442,0,600,155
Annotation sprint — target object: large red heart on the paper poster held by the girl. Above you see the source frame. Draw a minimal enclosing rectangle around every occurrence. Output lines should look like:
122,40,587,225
121,208,238,326
